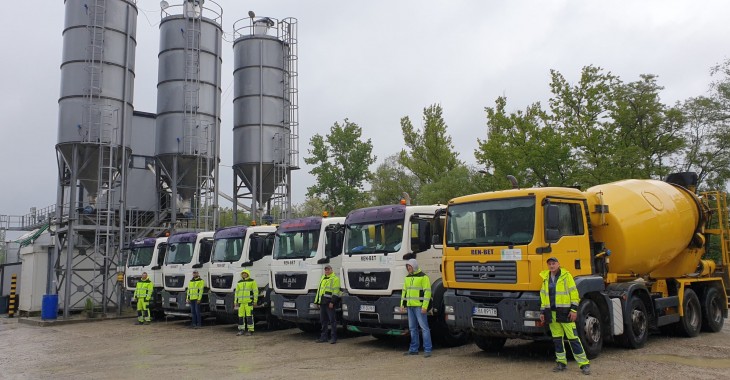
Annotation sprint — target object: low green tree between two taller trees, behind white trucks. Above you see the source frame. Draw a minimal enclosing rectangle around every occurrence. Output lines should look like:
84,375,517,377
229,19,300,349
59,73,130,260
370,154,420,205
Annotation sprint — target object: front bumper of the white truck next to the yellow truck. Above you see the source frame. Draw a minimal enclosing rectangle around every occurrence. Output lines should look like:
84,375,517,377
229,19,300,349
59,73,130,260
342,294,408,335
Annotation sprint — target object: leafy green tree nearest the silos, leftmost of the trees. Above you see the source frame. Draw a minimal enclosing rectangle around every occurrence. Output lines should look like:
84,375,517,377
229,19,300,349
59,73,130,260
304,119,376,215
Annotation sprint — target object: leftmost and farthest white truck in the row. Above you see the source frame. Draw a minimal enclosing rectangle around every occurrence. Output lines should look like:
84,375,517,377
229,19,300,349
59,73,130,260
124,237,167,318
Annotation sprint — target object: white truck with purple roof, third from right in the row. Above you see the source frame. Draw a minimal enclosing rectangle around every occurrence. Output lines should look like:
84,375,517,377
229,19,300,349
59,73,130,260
271,216,345,331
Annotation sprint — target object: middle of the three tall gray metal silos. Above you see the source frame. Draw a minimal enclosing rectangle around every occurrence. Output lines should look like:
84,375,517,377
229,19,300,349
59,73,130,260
155,0,223,230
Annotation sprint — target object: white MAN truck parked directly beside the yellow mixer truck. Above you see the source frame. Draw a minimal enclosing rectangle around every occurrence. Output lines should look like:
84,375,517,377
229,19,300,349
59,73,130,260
341,205,468,345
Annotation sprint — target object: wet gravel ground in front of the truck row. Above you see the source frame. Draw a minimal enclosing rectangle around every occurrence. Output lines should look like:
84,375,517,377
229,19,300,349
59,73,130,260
0,318,730,380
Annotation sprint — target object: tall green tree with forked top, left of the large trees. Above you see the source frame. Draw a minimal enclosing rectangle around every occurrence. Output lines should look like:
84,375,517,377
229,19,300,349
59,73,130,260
398,104,462,184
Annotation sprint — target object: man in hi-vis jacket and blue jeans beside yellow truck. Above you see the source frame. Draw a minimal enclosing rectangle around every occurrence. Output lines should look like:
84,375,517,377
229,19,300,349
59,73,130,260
401,259,433,358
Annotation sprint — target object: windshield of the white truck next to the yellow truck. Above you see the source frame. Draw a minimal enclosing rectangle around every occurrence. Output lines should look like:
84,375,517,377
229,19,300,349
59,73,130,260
345,220,403,255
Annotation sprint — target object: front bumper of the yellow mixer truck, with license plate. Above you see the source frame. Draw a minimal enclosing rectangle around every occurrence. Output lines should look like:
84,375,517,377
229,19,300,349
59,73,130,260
444,289,549,340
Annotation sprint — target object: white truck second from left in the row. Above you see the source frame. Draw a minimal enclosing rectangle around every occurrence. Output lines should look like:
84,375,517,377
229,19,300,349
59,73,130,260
162,231,214,317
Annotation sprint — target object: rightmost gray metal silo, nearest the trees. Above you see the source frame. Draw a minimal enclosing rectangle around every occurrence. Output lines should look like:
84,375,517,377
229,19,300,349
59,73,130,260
233,12,299,220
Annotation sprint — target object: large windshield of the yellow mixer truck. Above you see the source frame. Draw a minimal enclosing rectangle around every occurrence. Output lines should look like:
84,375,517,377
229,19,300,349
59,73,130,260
446,197,535,247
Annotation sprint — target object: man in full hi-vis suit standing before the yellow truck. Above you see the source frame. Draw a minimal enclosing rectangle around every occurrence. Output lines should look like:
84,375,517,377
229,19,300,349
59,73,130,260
540,257,591,375
